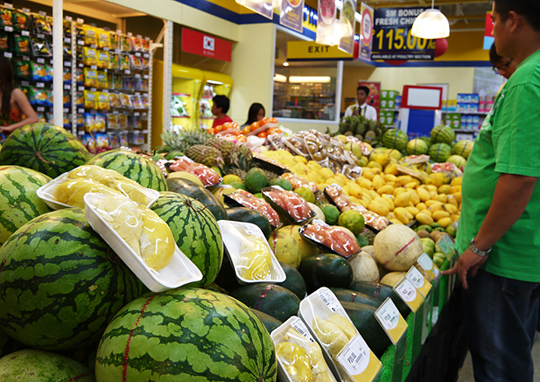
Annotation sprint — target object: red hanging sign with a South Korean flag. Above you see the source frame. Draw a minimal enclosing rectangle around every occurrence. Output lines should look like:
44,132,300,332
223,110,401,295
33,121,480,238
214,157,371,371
182,28,232,62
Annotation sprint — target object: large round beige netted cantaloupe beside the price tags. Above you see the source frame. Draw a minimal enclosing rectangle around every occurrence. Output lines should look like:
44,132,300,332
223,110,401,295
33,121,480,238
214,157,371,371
373,224,424,271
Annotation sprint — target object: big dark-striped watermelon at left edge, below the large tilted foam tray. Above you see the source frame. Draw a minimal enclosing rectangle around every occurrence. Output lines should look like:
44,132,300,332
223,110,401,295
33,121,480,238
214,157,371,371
0,208,143,350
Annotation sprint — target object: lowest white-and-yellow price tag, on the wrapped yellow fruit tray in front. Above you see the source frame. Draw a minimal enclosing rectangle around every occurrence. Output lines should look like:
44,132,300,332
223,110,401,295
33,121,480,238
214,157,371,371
337,335,382,382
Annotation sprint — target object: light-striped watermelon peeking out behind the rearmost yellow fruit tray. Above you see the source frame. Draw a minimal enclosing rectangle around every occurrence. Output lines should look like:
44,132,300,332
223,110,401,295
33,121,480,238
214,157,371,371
86,149,167,191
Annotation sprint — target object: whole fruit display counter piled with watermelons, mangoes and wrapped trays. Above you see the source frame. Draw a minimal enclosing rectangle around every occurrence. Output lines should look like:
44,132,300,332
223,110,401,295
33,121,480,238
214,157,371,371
0,120,464,382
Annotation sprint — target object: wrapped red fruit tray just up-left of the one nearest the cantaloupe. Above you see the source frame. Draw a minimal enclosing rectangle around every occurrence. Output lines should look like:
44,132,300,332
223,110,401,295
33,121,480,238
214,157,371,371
262,186,314,224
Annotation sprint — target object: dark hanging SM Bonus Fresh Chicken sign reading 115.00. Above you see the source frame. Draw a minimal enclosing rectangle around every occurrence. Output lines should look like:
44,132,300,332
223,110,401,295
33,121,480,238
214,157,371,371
371,8,435,60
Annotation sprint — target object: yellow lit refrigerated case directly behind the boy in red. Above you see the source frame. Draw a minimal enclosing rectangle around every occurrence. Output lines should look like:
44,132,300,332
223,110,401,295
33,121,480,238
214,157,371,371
199,70,232,128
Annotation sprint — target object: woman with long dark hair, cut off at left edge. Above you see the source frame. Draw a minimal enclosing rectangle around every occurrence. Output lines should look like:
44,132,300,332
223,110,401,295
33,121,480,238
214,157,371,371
0,57,38,139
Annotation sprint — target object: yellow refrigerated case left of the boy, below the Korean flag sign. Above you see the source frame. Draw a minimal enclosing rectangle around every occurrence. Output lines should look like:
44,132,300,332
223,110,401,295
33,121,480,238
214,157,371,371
152,60,204,145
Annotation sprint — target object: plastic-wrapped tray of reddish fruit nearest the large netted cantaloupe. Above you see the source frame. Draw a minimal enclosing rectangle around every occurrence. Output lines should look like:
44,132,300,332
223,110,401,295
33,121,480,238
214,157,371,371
299,220,360,258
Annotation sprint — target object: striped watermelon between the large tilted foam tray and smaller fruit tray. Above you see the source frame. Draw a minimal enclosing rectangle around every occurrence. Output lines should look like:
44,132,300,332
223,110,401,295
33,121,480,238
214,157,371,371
150,191,223,286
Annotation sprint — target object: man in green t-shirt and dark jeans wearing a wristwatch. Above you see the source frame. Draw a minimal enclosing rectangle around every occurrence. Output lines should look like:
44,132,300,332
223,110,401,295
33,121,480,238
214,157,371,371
443,0,540,382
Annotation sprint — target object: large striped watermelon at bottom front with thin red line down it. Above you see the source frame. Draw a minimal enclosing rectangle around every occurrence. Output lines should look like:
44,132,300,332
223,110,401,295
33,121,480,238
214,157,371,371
95,288,277,382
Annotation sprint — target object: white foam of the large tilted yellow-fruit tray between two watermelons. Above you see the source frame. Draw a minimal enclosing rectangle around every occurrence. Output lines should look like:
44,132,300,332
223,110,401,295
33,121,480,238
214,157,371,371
84,193,203,292
